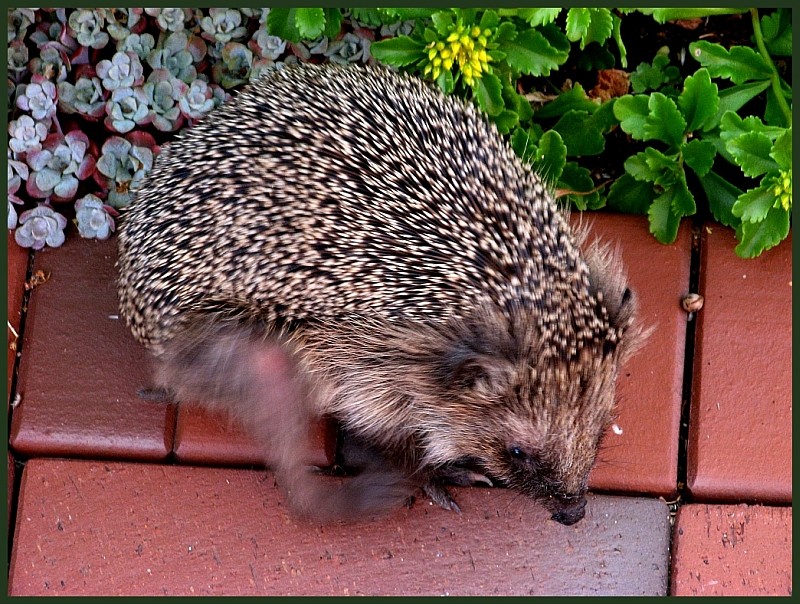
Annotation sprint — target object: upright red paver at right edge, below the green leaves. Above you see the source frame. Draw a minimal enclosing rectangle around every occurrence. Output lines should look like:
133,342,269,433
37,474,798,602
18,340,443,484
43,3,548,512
688,226,792,503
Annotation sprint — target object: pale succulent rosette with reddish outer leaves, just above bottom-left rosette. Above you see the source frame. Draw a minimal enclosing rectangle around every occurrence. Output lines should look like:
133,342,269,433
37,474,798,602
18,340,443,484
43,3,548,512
25,130,95,201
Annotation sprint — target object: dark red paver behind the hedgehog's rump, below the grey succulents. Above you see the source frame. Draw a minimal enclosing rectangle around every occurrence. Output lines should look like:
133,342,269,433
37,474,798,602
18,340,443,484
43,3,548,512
11,234,175,460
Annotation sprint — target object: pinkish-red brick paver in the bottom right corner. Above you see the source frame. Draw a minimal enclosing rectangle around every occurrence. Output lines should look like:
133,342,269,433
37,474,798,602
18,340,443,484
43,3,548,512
670,505,792,596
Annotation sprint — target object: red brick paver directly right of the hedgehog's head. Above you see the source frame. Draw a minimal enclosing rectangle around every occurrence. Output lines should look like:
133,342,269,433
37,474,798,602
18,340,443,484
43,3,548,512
585,215,691,497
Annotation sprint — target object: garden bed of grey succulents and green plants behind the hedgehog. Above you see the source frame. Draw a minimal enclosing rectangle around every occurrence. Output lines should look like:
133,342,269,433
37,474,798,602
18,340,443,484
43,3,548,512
8,7,792,256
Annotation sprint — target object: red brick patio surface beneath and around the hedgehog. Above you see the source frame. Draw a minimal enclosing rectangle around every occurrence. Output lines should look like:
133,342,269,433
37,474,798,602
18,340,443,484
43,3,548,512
8,215,792,595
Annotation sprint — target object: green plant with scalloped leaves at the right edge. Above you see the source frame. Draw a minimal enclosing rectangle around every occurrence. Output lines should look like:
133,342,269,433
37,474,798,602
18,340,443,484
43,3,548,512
608,10,792,257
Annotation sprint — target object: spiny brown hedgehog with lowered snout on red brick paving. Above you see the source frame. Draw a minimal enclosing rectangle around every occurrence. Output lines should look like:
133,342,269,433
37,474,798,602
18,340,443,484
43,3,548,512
118,65,641,525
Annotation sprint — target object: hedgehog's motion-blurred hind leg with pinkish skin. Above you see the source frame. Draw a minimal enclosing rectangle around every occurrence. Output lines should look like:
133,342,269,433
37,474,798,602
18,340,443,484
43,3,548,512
157,313,417,521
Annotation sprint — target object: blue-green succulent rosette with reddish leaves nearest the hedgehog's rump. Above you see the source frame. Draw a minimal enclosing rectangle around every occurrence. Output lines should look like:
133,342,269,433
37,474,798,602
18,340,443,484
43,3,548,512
95,132,158,208
